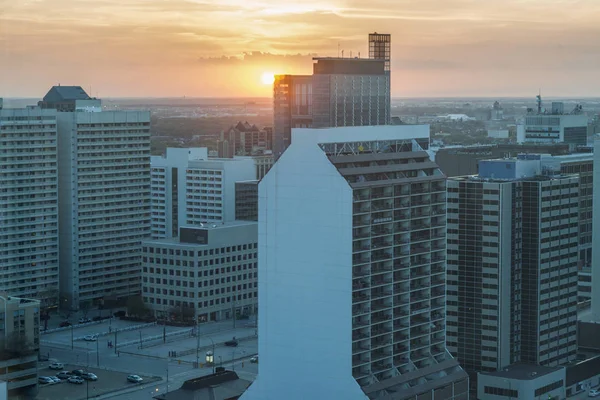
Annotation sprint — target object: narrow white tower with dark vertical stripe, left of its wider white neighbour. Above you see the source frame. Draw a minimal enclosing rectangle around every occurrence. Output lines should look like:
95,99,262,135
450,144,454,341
150,147,208,239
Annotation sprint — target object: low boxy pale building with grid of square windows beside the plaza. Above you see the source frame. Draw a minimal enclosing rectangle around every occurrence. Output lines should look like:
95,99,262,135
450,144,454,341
142,221,258,321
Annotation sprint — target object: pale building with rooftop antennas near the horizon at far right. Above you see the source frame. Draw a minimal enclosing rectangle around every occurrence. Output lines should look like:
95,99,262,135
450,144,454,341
517,96,588,149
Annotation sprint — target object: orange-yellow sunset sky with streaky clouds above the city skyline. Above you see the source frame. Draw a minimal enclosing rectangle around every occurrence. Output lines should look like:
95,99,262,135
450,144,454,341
0,0,600,97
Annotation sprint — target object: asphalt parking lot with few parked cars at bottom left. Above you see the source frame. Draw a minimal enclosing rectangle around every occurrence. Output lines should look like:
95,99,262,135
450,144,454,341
37,365,160,400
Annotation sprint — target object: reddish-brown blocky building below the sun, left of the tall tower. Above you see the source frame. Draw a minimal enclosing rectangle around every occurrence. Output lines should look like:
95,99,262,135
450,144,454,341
217,121,273,158
